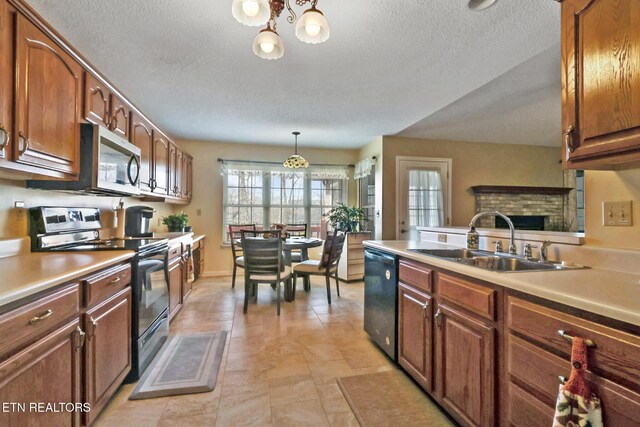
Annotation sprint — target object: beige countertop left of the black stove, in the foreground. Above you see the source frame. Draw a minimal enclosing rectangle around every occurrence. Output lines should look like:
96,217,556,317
0,250,135,311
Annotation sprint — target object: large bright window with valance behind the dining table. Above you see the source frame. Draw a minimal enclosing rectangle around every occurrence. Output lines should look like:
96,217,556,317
221,160,348,243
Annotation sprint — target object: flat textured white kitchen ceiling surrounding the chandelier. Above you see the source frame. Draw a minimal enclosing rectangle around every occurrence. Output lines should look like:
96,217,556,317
28,0,560,148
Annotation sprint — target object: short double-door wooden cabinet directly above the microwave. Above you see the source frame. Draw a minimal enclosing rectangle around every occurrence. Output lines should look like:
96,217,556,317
84,72,131,140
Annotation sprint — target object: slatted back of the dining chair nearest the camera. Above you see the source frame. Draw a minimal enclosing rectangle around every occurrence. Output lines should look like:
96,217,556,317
240,230,283,277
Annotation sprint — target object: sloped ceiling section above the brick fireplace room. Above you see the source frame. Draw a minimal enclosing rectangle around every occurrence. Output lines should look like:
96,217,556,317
398,44,562,146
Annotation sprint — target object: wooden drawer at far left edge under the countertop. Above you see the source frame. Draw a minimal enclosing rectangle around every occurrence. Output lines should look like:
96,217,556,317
0,283,80,353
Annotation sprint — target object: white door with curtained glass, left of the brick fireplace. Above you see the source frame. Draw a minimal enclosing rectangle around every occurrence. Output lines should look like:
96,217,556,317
396,157,451,240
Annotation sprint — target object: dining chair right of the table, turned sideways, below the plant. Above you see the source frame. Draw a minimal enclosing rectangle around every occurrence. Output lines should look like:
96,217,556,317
291,231,346,304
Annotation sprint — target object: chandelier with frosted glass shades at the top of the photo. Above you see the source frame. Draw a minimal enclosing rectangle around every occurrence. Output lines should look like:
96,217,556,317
231,0,330,59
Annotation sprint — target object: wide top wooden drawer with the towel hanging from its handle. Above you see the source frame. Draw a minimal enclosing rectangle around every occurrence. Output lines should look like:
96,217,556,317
507,296,640,387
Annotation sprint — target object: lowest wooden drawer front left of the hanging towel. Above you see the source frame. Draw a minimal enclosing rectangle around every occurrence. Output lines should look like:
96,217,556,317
508,384,555,427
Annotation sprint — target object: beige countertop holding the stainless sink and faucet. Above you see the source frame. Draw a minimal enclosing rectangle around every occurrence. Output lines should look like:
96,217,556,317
364,240,640,326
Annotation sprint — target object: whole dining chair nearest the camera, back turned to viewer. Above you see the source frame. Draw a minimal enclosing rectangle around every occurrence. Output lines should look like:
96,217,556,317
240,230,291,316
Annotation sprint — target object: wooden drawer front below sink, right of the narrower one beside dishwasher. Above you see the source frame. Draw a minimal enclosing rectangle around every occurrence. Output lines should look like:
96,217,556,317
437,274,496,320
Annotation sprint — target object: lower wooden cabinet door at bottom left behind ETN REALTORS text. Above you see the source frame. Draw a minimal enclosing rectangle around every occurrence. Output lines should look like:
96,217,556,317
0,319,82,426
